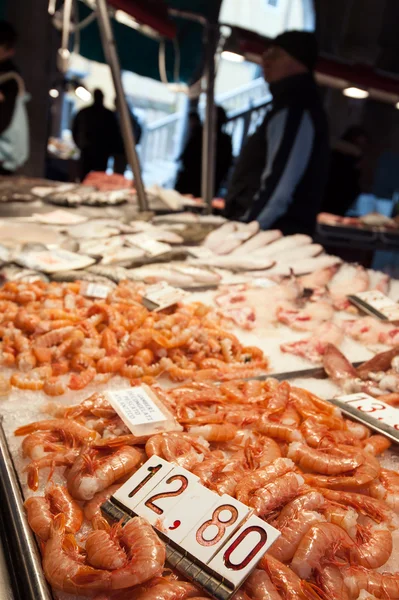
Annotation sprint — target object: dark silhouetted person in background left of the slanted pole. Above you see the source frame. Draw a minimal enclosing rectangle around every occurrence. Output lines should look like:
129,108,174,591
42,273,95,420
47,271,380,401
72,89,118,180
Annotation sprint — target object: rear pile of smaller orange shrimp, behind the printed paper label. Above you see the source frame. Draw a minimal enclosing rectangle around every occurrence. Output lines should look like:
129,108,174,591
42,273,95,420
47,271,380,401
0,281,268,396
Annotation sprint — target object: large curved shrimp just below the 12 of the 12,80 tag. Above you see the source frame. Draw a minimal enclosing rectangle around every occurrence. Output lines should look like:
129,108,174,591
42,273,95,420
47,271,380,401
110,517,166,590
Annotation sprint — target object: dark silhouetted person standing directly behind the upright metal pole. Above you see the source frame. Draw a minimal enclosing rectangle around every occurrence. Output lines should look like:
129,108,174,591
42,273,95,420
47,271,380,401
175,106,233,198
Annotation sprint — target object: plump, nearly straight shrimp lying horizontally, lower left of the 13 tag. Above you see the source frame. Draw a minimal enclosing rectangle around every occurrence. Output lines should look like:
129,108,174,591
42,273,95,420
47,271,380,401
287,442,364,475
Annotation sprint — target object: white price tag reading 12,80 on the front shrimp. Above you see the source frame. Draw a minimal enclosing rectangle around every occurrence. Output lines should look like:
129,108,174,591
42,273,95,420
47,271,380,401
111,456,280,593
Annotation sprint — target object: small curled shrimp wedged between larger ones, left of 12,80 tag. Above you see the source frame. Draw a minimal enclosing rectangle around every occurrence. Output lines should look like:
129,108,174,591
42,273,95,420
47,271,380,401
85,519,128,571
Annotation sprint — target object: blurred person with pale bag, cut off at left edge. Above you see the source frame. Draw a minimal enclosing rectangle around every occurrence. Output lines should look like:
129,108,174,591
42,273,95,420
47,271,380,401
0,20,29,175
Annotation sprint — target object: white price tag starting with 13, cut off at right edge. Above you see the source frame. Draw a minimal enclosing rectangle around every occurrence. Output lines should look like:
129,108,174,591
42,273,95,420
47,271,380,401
329,392,399,444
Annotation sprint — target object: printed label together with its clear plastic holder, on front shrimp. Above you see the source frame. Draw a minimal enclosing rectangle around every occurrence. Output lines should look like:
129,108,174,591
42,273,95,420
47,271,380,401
105,384,183,436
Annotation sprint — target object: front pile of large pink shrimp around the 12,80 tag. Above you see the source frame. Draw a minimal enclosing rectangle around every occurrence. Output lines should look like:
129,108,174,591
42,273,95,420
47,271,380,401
15,379,399,600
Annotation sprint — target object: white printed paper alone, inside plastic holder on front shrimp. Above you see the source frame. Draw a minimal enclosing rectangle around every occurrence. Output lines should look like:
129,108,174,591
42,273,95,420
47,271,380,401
106,386,167,428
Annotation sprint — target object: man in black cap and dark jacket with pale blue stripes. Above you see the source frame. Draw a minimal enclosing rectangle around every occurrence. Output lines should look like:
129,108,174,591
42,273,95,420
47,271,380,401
225,31,329,235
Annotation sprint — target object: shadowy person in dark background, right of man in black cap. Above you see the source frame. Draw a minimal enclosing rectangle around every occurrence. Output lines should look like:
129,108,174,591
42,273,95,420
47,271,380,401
321,125,369,216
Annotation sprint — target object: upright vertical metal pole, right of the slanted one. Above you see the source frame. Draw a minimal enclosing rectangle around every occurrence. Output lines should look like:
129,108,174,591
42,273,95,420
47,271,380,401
201,23,219,212
